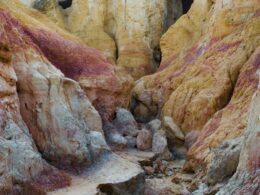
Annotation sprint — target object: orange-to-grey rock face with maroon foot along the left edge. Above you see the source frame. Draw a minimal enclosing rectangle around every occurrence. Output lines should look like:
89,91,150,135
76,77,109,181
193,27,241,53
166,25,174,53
0,24,70,194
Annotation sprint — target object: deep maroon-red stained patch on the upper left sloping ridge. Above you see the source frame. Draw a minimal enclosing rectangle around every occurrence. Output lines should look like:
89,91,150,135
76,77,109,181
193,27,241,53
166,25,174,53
24,28,114,80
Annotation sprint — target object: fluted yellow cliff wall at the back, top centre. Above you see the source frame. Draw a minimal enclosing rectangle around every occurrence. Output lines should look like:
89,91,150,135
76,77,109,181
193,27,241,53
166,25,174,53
23,0,182,79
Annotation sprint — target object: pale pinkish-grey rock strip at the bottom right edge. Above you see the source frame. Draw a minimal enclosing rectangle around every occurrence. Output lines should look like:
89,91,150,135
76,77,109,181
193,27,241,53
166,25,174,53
217,85,260,195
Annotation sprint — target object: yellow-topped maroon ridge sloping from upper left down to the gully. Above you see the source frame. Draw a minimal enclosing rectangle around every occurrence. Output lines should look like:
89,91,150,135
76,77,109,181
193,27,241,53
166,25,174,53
13,1,133,121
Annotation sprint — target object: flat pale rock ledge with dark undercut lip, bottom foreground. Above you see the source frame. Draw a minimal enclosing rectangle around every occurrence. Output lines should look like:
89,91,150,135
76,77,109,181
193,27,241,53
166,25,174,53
50,155,145,195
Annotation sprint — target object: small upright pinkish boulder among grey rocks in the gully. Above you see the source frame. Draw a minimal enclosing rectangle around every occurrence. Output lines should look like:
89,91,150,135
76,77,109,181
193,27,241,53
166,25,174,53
136,129,153,150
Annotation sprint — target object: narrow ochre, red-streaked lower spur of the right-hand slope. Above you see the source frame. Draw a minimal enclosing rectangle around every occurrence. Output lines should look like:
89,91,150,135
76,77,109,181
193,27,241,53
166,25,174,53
188,48,260,172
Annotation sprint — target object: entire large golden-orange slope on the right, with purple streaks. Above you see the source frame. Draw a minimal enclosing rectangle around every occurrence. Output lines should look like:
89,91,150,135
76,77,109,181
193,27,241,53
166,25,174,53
131,0,260,172
